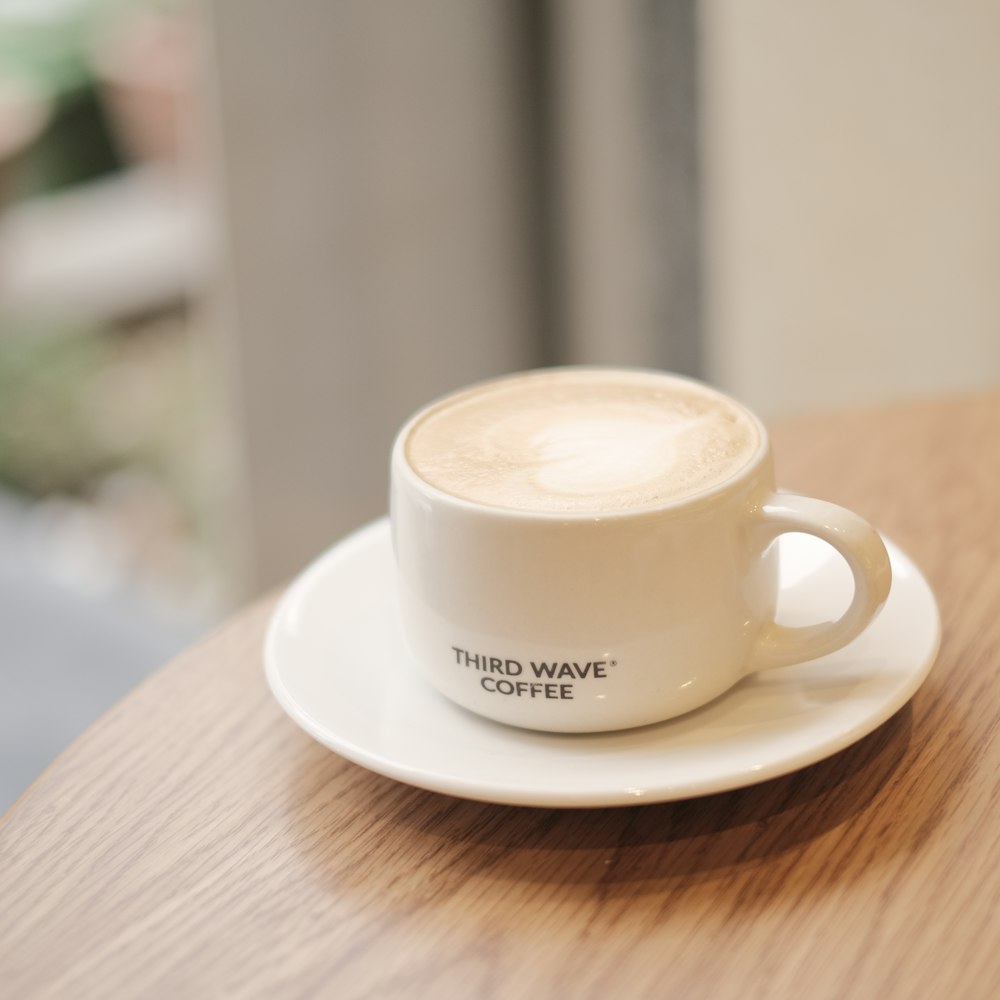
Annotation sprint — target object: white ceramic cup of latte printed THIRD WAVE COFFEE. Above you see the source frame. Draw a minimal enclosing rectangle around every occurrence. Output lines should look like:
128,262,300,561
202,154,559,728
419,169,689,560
390,368,891,732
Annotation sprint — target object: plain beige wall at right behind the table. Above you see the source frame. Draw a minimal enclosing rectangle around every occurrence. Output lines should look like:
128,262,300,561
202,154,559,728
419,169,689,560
701,0,1000,413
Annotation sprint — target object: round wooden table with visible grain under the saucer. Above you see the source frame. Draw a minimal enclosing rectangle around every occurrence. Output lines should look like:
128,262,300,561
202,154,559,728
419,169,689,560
0,395,1000,1000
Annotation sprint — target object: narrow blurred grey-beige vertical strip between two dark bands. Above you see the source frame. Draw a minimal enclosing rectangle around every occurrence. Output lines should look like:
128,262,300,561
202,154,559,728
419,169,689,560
550,0,702,375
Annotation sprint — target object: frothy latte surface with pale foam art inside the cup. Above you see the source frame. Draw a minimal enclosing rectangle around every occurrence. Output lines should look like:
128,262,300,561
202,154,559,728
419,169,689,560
405,368,761,513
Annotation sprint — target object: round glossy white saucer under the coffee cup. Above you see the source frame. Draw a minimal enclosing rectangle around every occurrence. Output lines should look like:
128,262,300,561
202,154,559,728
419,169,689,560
265,519,940,806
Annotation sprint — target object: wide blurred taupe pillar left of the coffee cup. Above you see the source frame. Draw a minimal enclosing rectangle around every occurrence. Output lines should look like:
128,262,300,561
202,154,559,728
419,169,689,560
208,0,539,591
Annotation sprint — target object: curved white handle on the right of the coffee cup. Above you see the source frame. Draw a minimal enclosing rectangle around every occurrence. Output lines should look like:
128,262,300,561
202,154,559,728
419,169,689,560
747,492,892,673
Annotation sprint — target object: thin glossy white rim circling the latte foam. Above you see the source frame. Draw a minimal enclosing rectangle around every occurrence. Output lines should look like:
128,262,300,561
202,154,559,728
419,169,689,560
390,365,771,522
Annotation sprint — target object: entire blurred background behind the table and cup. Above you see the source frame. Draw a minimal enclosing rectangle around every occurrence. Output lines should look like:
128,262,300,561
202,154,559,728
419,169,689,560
0,0,1000,811
